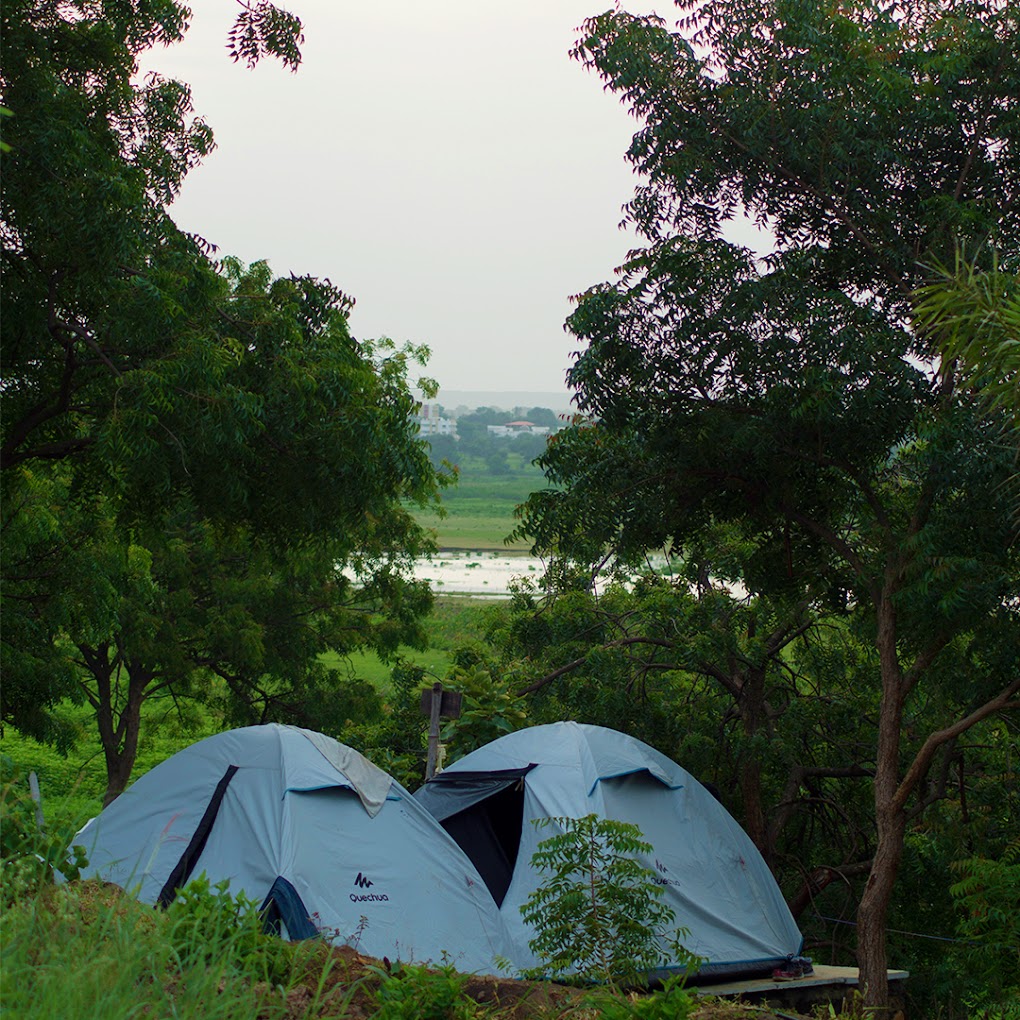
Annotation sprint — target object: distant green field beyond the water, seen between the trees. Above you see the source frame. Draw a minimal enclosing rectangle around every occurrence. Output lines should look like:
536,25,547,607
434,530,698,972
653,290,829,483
418,457,546,550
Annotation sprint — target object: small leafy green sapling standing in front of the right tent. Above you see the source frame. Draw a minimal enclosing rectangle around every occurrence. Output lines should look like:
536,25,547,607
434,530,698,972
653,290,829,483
521,815,696,988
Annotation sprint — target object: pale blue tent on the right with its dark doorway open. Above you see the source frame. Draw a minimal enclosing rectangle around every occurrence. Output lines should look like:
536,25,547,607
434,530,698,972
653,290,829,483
415,722,803,976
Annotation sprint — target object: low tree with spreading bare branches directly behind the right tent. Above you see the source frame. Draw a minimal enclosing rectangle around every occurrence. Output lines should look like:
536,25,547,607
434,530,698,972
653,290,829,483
503,572,872,873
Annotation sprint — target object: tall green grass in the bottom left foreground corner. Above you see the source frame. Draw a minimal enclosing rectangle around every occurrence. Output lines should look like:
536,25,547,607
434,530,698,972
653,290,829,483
0,880,344,1020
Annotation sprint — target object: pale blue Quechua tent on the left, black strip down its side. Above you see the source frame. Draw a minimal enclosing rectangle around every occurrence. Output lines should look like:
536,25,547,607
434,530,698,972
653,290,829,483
78,725,509,973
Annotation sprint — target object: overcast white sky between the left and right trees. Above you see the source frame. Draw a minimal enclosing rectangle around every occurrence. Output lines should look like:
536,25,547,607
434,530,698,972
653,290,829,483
146,0,767,392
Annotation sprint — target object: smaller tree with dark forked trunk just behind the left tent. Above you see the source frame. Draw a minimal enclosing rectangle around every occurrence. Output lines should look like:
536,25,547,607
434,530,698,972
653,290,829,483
55,493,431,804
